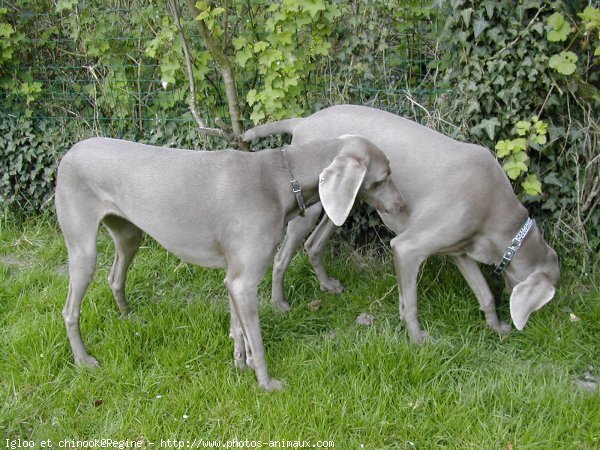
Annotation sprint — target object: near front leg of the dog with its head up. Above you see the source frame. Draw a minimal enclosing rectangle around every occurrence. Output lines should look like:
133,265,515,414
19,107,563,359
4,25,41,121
225,273,283,391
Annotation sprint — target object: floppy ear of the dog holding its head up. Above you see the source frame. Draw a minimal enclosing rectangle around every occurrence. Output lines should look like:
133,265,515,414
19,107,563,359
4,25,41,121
319,155,367,227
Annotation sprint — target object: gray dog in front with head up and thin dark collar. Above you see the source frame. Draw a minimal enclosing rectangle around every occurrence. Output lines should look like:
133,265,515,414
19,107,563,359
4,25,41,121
56,136,404,390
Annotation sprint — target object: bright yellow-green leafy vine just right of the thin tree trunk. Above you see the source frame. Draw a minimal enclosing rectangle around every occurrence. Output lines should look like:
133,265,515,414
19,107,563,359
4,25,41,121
233,0,341,123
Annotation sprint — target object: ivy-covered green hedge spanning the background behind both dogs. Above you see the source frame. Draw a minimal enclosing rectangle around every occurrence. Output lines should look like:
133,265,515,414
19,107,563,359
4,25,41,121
0,0,600,253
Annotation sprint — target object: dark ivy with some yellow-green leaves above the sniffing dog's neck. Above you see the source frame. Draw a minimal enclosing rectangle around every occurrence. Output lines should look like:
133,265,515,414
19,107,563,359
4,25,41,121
436,0,600,245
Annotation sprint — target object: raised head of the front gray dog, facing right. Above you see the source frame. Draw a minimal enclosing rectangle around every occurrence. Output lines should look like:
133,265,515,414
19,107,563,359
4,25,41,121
319,135,406,226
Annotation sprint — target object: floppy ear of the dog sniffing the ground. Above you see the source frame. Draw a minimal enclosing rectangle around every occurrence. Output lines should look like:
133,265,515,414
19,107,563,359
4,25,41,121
510,272,555,330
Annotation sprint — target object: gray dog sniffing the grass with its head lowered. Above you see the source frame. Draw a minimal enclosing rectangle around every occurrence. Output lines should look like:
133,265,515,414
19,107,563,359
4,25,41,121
244,105,559,343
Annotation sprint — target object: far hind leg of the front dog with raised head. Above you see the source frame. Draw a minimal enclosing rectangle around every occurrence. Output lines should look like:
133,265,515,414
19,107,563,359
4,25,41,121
102,216,142,315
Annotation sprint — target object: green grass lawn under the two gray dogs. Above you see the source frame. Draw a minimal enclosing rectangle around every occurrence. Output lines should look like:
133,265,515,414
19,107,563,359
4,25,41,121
0,220,600,449
